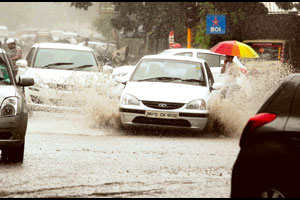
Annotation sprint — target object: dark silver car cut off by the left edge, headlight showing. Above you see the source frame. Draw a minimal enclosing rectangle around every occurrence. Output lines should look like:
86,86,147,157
0,49,34,162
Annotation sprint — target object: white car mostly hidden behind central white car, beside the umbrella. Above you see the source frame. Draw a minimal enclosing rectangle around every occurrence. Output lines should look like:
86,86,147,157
160,48,247,84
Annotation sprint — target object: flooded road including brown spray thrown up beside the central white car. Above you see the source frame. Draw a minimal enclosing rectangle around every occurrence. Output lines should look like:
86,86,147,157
0,60,288,198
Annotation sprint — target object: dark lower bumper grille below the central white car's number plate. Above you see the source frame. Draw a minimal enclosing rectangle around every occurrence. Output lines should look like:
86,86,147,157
132,116,191,127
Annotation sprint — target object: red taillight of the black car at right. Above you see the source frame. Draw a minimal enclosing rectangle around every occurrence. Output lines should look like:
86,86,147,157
244,113,277,132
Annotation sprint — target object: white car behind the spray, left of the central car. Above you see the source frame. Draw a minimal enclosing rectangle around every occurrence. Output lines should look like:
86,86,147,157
17,43,117,110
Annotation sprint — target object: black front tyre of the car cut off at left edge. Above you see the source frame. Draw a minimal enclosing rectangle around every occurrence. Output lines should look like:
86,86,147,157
2,143,24,163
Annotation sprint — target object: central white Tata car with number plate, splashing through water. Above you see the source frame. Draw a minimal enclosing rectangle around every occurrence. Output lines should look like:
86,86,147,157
120,55,217,131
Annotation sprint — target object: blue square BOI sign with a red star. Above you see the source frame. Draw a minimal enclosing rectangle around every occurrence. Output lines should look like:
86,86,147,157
206,15,226,34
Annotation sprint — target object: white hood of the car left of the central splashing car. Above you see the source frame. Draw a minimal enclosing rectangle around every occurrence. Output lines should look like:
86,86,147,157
29,68,107,85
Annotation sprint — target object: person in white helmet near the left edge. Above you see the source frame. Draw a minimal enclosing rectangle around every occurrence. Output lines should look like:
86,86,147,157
6,38,22,75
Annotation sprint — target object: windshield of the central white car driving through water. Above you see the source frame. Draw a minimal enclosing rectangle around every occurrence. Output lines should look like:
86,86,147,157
131,59,206,86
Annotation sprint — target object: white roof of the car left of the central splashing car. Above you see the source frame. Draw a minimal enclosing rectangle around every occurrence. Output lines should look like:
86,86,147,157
32,43,93,51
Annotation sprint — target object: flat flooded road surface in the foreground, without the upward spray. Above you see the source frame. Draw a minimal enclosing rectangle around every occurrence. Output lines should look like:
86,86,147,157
0,112,239,198
